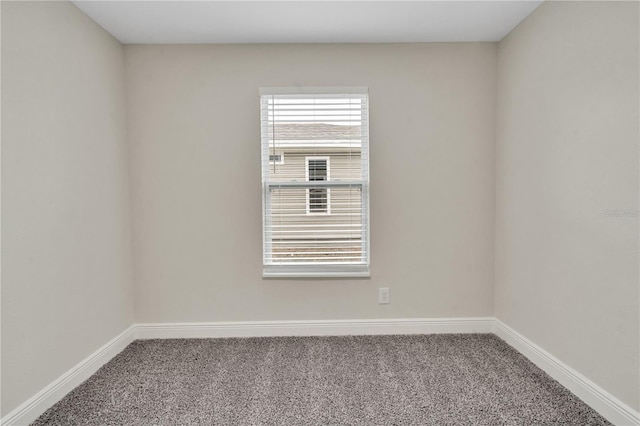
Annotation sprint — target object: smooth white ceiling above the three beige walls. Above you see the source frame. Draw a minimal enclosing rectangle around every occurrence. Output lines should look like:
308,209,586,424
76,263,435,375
73,0,542,43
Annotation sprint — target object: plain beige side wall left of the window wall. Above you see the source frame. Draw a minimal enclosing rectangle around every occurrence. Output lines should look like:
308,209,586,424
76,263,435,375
2,1,133,415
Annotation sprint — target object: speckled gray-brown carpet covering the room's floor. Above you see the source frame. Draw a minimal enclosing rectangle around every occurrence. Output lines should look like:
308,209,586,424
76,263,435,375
34,334,609,426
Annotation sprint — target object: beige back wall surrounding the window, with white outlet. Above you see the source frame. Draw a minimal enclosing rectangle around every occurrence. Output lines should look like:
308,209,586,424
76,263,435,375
125,43,497,322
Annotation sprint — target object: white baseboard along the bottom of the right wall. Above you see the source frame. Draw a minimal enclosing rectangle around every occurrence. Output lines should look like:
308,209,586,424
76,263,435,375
493,318,640,426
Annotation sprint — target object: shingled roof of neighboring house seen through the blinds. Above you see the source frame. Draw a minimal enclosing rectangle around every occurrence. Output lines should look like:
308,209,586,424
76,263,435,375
268,123,362,147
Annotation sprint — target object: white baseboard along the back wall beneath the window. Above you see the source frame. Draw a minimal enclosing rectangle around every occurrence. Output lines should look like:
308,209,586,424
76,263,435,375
136,317,493,339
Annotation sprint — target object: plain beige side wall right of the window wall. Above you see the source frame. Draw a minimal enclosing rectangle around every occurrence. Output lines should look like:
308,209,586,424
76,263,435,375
495,2,640,410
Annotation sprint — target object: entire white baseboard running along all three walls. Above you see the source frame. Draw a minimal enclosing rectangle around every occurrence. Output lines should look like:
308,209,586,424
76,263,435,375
0,317,640,426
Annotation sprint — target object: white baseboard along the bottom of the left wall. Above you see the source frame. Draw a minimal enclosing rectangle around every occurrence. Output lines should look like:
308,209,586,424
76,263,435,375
0,326,135,426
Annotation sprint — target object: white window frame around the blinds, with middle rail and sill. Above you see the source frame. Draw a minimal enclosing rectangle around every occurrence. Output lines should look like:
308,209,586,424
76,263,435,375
259,87,371,279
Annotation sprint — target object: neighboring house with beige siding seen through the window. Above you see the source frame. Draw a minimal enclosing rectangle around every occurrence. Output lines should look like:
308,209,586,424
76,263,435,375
269,123,363,262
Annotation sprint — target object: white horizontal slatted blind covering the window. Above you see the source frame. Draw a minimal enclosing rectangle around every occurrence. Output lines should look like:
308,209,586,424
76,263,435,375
260,87,369,277
